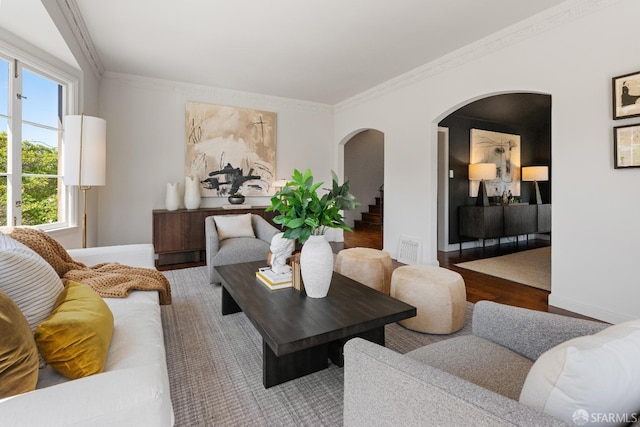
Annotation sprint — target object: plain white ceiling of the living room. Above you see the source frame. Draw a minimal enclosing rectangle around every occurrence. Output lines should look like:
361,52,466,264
0,0,563,104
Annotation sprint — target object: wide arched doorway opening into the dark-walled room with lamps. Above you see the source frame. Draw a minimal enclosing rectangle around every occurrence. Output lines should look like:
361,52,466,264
438,93,552,309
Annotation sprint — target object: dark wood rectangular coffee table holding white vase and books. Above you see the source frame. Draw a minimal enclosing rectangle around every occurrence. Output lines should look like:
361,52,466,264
215,261,416,388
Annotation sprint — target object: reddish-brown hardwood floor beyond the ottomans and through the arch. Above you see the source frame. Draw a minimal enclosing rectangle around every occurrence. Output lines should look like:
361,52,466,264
344,230,583,317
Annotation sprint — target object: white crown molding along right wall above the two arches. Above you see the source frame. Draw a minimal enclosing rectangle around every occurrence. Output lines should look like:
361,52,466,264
334,0,621,112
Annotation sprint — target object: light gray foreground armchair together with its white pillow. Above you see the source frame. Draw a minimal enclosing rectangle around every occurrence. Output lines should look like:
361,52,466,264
344,301,640,427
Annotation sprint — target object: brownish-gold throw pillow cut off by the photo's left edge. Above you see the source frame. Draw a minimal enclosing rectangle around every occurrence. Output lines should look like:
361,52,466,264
0,291,38,399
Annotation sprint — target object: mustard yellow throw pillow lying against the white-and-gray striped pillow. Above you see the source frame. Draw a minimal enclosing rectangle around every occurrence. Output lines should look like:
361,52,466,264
35,282,113,379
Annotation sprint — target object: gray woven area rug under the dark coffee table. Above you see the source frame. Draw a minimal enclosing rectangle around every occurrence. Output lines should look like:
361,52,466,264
161,267,473,427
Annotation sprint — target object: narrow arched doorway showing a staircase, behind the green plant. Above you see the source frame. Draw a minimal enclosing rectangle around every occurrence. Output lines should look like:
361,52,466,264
343,129,384,249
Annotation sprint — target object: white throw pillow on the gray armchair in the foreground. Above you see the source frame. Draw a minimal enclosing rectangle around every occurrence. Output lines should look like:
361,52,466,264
520,319,640,426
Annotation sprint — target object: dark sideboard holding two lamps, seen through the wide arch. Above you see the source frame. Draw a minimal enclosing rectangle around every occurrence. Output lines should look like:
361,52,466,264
458,203,551,245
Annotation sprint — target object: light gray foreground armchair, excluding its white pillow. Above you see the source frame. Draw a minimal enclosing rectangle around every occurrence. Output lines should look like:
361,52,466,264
344,301,608,427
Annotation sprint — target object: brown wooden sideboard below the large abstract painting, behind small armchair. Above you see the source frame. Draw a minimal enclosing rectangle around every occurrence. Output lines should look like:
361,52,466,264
153,206,277,267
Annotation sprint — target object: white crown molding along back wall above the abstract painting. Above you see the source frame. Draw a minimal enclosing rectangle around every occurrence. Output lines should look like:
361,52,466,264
103,71,333,114
